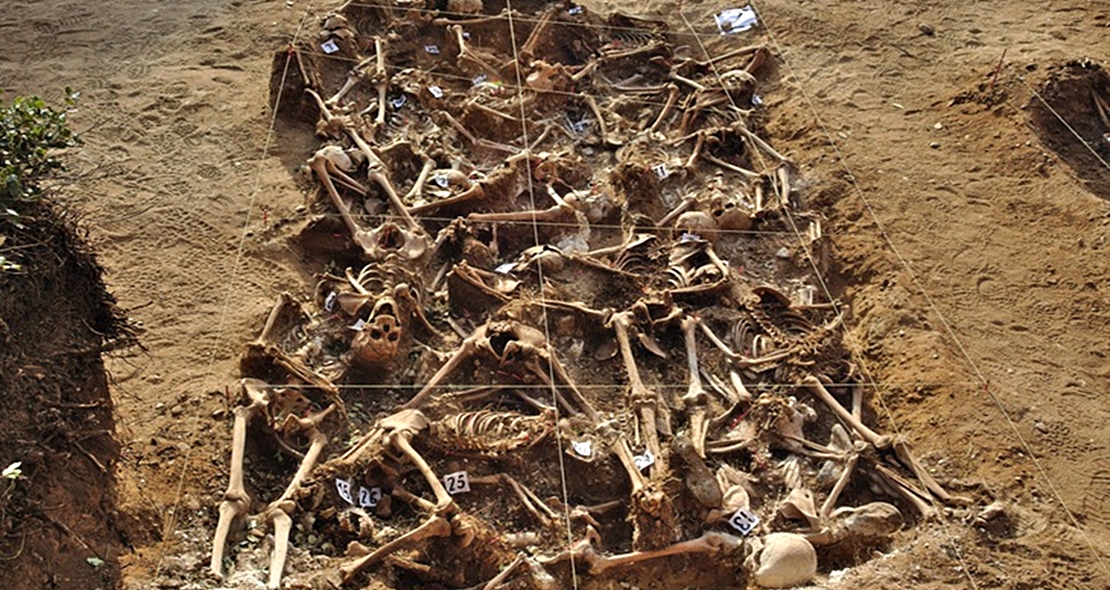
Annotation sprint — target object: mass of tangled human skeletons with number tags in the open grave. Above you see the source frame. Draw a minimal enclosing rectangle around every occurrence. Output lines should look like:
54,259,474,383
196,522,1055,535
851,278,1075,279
210,0,963,589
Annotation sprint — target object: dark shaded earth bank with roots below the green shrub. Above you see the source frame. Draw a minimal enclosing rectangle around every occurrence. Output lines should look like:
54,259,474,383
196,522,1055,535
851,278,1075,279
0,199,140,590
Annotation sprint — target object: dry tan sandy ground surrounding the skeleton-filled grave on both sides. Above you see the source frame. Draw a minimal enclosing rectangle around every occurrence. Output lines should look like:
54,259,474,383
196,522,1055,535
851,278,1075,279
0,0,1110,589
